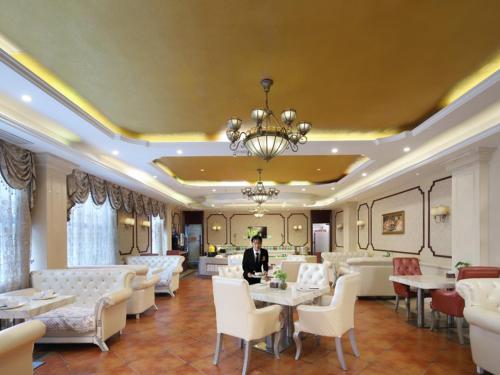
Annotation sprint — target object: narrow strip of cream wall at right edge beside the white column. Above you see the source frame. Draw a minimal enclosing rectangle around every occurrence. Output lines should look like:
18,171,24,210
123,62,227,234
488,148,500,267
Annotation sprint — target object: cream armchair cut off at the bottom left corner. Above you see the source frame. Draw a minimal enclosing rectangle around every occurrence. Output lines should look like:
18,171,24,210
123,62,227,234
0,320,45,375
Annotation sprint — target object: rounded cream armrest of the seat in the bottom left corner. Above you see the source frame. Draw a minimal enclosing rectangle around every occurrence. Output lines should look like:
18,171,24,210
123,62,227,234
0,320,46,356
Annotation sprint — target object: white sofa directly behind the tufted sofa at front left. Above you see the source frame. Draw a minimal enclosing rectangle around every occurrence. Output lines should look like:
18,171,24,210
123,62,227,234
71,264,162,319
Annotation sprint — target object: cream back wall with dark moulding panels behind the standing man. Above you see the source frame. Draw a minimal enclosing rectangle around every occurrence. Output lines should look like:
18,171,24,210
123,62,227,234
204,211,311,248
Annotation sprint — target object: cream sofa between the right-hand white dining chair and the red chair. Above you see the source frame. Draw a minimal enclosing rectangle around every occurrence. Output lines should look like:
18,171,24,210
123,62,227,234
339,257,394,297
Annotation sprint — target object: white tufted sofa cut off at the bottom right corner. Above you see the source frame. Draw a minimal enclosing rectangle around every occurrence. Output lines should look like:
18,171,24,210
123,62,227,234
456,278,500,374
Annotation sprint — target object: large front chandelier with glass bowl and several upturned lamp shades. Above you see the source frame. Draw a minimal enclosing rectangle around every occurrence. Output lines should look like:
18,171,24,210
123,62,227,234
226,78,311,161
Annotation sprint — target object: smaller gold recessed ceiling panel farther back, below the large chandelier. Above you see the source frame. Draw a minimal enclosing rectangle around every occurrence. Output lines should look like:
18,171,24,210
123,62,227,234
155,155,365,184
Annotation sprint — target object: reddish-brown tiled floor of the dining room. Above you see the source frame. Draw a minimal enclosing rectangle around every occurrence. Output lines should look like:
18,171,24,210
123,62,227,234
35,276,475,375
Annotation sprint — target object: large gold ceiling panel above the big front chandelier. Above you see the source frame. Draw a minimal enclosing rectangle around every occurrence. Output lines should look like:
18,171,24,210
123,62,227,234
0,0,500,139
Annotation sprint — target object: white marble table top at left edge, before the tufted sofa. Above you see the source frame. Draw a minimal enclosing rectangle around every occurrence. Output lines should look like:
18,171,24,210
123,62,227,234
0,288,76,319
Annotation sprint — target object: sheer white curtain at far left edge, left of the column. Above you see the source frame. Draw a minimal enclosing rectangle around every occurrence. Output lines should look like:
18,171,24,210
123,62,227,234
0,175,31,292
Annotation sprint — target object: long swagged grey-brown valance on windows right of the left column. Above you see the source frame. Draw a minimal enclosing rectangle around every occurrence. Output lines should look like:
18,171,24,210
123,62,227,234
67,169,165,221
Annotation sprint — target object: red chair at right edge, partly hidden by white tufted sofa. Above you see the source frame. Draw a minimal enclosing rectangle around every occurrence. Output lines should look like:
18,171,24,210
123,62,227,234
431,267,500,344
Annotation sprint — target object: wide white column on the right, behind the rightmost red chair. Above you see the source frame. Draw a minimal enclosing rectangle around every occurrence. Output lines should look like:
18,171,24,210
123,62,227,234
447,148,493,266
